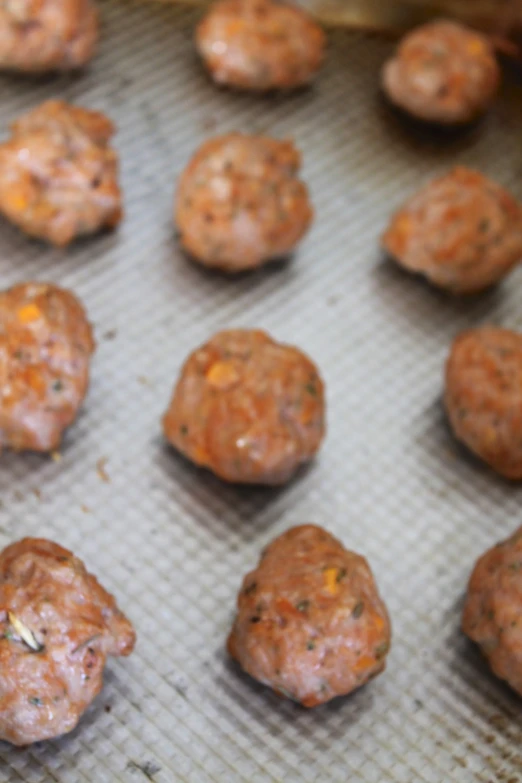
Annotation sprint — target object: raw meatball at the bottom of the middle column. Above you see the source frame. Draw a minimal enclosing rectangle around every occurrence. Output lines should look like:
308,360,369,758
228,525,391,707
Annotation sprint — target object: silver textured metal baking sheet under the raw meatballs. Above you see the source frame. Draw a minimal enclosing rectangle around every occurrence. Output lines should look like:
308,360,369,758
0,0,522,783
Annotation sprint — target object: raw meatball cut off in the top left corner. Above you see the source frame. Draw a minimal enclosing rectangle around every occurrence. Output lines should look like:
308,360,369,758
0,0,98,73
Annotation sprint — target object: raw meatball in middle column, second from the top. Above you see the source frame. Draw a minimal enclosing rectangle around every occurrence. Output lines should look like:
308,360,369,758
174,133,313,272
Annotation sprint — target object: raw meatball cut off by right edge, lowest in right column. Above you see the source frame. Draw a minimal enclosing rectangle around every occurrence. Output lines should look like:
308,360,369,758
462,527,522,696
